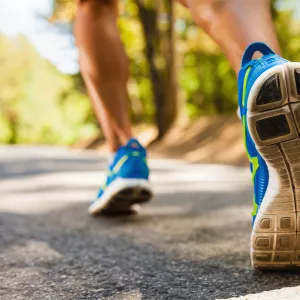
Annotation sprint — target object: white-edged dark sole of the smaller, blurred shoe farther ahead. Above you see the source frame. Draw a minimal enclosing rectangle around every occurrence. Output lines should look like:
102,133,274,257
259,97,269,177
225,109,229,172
89,178,153,215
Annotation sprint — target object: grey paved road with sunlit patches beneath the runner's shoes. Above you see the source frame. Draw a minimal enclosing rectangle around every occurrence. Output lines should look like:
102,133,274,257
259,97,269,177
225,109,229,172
0,147,300,300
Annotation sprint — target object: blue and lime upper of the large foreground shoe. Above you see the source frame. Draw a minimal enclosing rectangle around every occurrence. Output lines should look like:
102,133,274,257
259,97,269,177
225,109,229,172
238,42,287,223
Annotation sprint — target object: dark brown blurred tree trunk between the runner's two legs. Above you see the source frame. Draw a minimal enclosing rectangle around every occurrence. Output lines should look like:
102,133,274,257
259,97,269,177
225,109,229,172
135,0,177,139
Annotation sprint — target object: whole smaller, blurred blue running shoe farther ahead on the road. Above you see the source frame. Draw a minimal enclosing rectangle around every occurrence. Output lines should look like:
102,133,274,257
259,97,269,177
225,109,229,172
89,139,152,215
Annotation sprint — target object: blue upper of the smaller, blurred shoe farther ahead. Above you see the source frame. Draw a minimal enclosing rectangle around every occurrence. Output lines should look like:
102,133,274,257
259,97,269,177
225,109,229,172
97,139,149,199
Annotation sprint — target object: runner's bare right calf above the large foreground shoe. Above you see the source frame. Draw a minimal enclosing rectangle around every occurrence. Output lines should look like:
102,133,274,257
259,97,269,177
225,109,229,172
179,0,280,73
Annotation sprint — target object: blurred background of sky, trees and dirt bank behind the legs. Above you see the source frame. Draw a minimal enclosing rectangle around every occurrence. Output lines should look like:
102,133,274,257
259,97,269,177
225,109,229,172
0,0,300,163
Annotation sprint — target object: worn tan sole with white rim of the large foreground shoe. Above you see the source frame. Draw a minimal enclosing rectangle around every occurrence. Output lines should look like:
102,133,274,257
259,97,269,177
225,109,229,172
247,63,300,269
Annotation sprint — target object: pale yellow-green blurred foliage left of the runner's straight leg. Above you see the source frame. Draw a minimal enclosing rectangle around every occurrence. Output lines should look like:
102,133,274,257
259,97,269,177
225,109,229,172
0,36,96,144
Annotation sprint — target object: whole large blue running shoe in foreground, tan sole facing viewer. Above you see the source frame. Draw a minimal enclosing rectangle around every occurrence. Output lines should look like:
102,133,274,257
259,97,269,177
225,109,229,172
238,43,300,269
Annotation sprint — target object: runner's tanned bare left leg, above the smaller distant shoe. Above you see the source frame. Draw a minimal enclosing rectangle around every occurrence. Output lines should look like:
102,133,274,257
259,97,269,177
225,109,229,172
75,0,132,152
